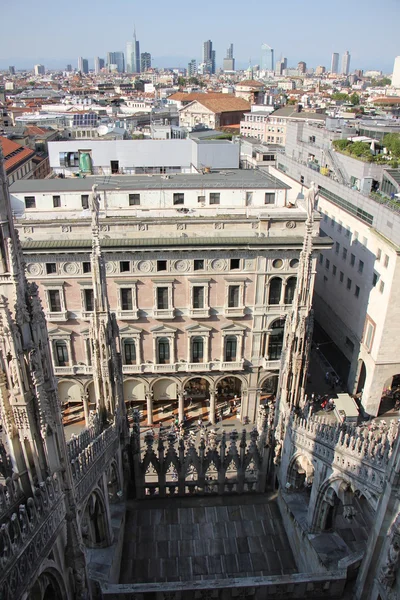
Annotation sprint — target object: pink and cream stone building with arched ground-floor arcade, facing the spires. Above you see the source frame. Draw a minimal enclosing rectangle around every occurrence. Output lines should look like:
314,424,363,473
11,171,329,423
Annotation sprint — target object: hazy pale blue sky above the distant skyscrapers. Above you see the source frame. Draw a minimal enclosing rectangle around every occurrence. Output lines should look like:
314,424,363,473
0,0,400,72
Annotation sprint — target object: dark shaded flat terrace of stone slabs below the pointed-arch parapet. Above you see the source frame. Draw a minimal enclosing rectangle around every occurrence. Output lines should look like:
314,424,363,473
120,494,298,584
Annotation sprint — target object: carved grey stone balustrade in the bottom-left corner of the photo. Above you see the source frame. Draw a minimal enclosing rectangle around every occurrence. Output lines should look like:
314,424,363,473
0,475,66,600
